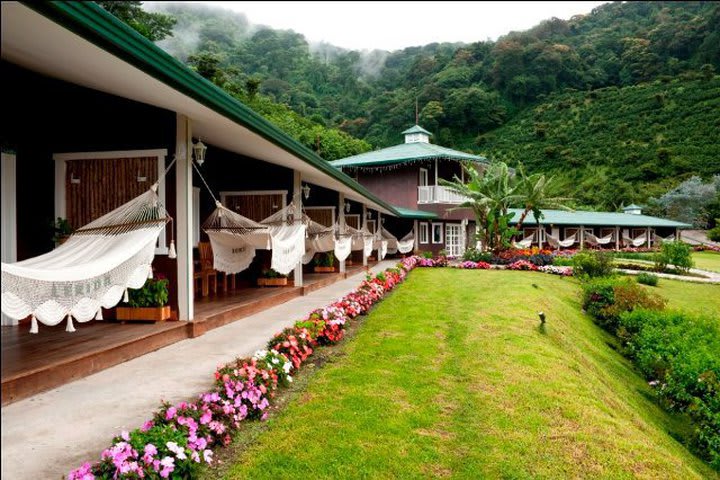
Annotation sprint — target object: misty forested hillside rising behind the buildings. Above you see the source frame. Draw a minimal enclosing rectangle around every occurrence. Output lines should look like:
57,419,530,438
100,2,720,225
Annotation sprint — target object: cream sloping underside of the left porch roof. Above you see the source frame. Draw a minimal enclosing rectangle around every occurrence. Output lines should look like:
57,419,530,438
2,2,395,215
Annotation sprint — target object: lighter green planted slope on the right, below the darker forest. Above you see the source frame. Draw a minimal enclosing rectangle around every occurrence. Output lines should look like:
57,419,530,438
480,76,720,207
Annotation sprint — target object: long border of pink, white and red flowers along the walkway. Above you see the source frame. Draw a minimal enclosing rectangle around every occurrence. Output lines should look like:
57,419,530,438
67,257,420,480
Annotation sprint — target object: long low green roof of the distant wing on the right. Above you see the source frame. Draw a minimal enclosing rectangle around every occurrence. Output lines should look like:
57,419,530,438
510,208,691,228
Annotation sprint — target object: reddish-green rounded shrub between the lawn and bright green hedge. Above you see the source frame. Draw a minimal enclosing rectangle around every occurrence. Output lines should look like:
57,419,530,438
583,277,666,333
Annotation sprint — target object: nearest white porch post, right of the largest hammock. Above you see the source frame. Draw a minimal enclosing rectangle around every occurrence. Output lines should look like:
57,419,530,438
174,115,195,321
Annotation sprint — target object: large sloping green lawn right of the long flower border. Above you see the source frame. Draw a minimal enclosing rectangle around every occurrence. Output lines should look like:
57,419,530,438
218,269,717,479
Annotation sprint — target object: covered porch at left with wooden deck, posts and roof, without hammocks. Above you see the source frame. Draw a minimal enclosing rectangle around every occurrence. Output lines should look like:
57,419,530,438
2,3,395,404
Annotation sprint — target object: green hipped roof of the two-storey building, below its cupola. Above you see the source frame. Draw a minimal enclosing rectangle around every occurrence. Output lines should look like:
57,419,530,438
330,142,488,168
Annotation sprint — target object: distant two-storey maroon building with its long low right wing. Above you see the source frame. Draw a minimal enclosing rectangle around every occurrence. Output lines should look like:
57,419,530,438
331,125,690,256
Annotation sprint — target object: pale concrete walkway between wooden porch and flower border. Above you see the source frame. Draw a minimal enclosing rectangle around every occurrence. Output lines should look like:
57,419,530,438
2,260,397,480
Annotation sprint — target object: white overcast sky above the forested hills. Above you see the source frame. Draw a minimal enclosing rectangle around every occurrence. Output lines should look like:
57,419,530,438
158,1,606,50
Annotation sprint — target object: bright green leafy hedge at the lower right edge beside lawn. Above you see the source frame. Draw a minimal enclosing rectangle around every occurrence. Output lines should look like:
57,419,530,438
617,309,720,469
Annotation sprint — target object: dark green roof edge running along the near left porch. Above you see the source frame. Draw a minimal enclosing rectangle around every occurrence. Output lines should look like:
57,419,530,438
21,1,404,214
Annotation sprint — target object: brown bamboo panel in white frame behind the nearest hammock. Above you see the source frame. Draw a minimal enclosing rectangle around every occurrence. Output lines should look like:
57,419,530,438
65,157,157,229
